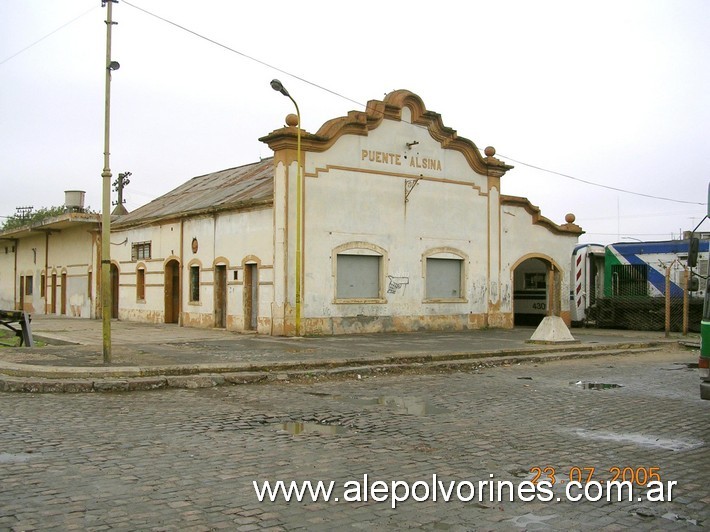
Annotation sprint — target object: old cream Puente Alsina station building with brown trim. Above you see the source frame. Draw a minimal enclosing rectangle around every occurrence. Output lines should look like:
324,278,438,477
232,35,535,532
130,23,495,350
0,90,582,335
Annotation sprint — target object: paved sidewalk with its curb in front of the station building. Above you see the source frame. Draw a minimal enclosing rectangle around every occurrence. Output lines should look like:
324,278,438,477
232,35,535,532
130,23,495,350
0,316,697,392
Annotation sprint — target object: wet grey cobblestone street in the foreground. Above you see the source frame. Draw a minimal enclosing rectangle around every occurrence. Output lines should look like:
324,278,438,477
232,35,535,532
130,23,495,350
0,348,710,530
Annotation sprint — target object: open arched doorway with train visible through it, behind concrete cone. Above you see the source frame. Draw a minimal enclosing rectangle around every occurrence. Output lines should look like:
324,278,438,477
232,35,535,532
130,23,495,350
513,257,551,326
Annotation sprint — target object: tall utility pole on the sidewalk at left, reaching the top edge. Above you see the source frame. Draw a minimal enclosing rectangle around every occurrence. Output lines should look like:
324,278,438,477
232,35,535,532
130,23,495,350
101,0,121,364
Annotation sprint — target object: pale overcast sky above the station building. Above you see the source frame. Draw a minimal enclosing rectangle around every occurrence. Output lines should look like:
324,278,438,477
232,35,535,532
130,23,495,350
0,0,710,244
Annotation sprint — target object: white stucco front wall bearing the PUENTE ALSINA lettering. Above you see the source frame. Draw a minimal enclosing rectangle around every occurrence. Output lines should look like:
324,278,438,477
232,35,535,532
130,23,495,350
291,116,498,329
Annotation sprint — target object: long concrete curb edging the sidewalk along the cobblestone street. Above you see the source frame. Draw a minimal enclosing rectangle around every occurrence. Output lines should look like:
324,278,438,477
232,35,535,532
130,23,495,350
0,341,668,393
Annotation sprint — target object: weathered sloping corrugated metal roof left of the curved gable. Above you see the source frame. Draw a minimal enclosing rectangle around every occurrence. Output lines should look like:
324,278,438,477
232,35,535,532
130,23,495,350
113,157,274,227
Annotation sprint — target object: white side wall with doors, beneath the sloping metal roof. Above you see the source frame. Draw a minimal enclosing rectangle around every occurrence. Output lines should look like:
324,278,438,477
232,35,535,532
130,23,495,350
112,208,273,333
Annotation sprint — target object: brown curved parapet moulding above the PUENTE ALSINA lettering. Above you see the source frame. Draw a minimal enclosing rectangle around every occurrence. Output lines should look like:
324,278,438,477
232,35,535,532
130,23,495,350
259,89,513,178
